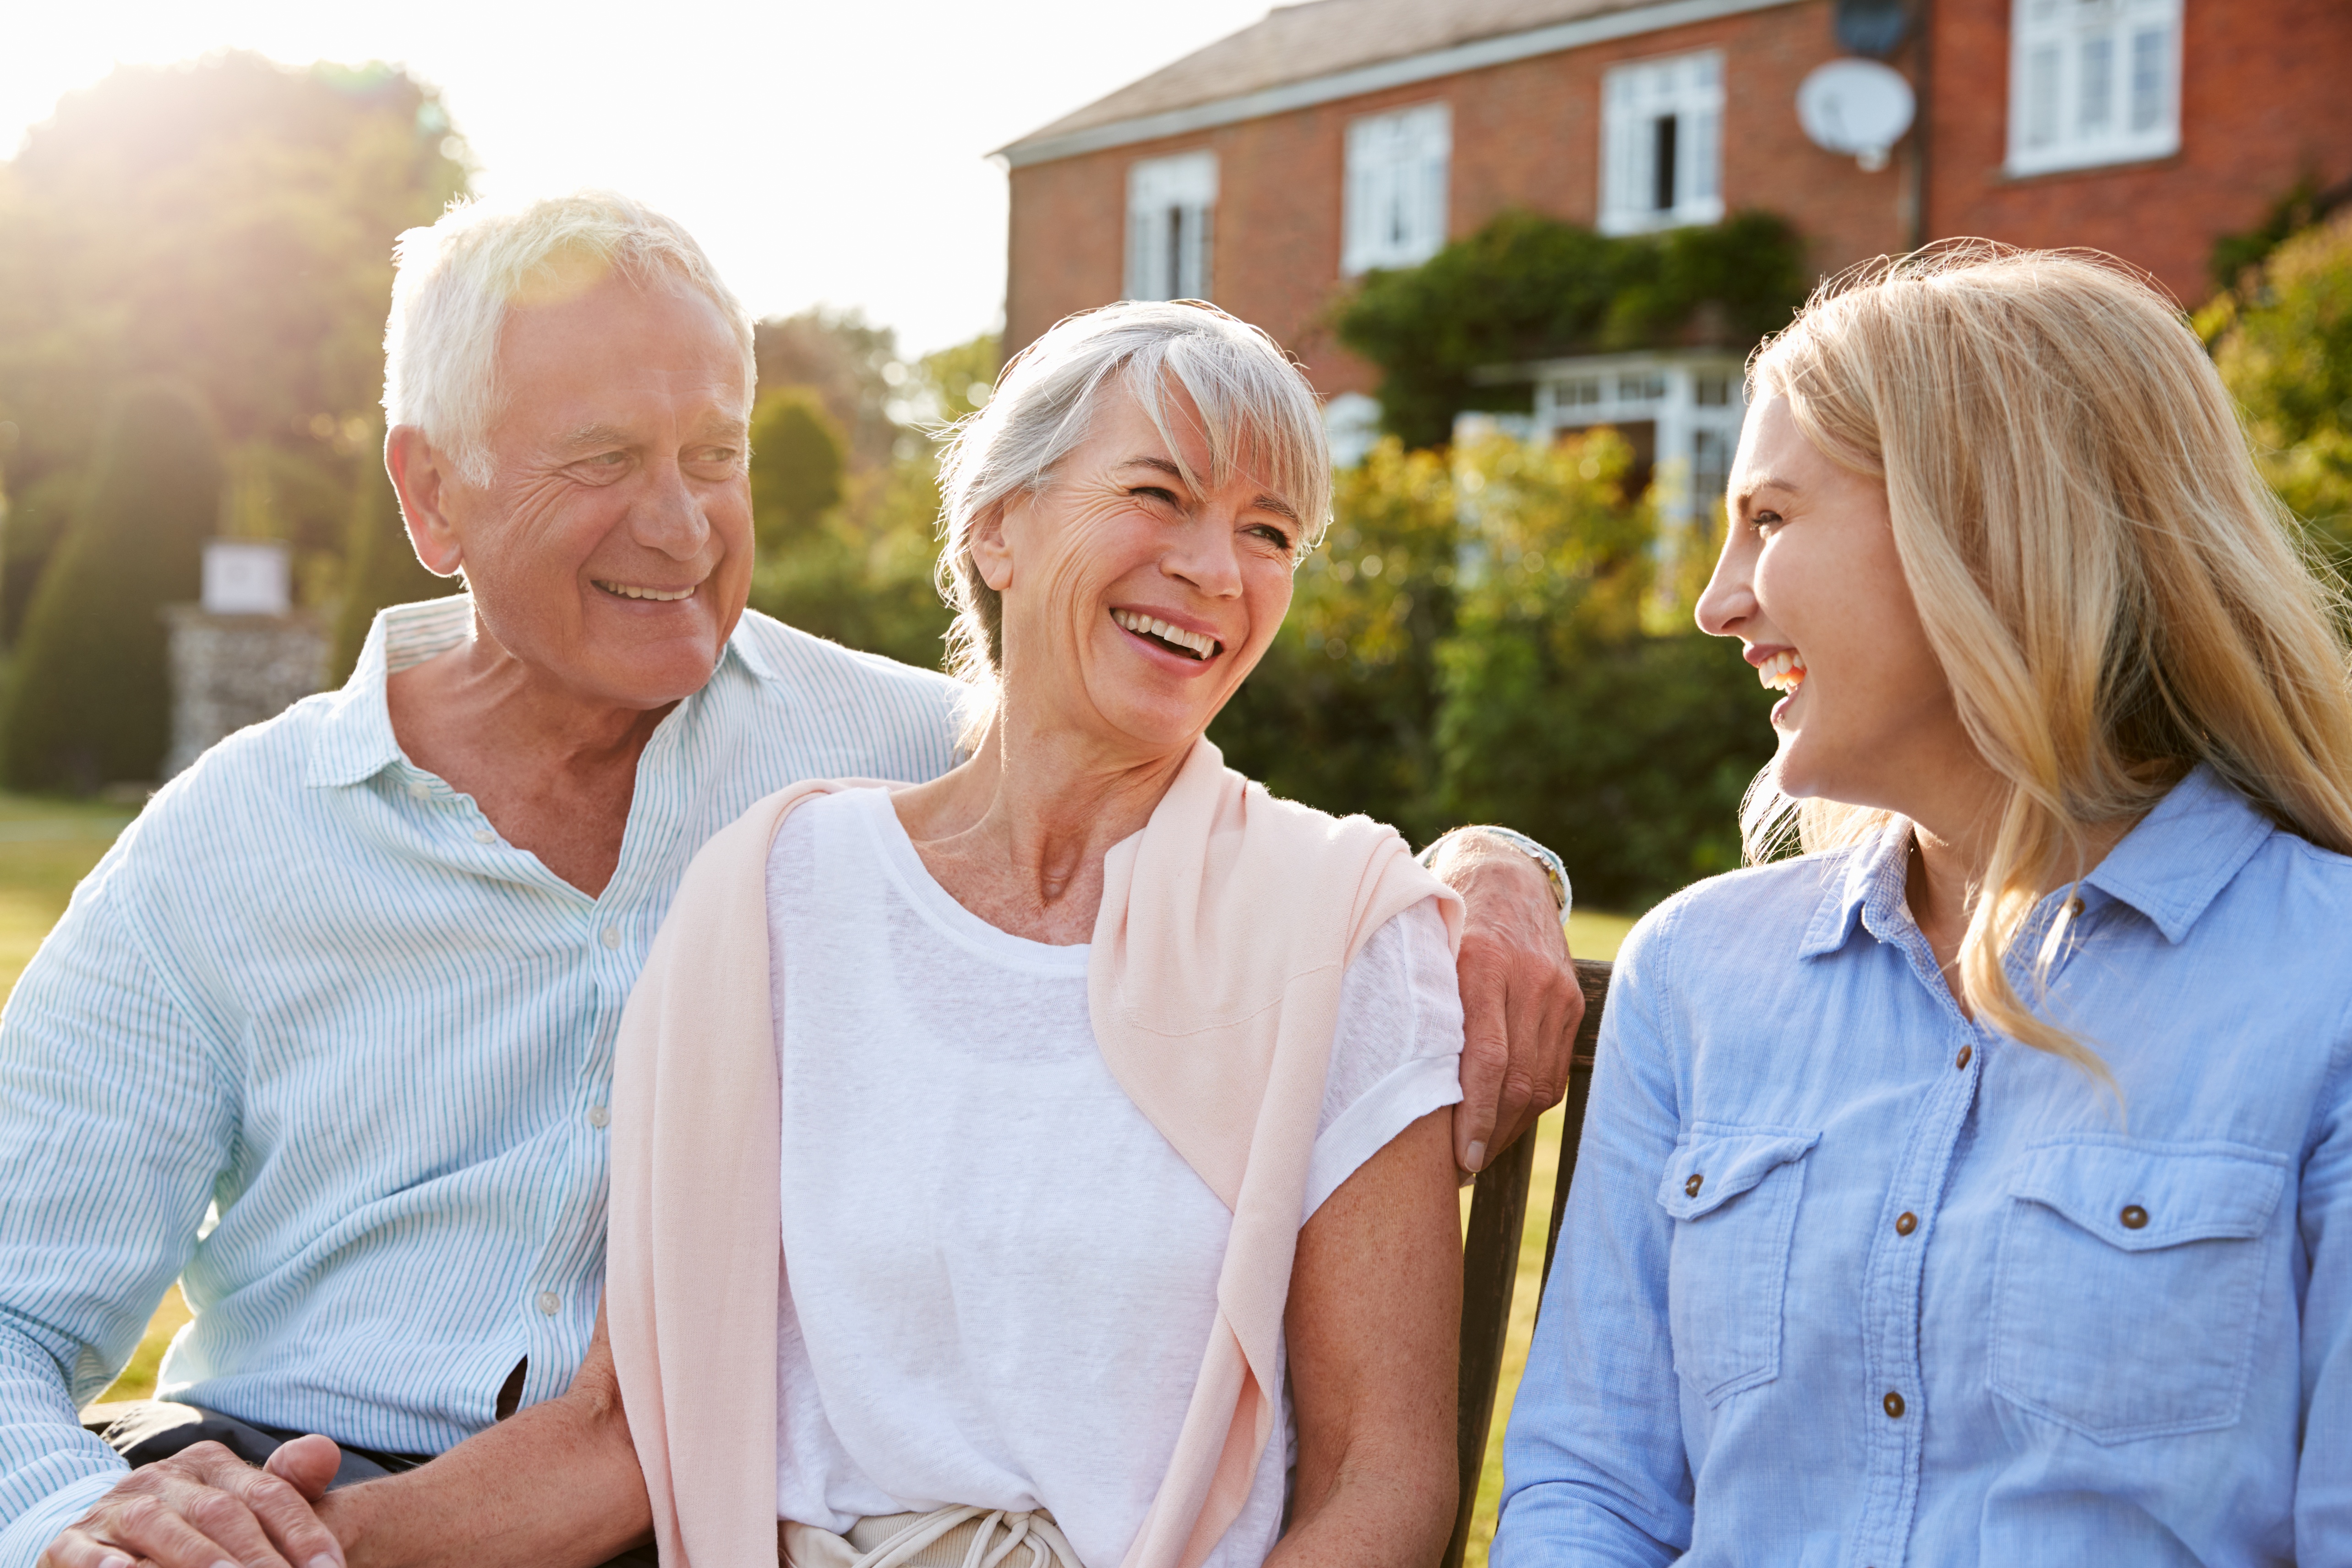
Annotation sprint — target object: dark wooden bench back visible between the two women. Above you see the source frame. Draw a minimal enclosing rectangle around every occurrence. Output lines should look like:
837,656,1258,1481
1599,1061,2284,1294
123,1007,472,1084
1444,959,1609,1568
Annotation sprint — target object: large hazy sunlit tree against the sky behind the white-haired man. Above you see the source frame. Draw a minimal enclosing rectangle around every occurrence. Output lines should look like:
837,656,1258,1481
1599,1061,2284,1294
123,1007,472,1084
0,54,466,644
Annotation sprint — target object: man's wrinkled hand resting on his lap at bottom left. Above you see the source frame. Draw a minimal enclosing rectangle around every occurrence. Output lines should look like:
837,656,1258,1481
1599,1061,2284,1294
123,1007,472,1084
38,1437,344,1568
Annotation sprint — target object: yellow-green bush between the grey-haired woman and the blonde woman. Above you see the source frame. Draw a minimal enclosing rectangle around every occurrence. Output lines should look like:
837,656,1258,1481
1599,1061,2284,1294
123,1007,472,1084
1211,432,1774,907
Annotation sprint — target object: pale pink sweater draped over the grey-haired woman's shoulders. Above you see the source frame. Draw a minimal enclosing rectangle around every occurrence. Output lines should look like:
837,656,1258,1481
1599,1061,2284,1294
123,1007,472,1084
605,741,1461,1568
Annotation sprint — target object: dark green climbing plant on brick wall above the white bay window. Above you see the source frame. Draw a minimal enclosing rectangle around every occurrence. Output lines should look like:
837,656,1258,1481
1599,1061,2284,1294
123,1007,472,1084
1334,212,1813,447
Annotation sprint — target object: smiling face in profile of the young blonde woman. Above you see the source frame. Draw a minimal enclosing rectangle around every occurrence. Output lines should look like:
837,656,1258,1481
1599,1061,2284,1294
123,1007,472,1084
1698,397,1975,816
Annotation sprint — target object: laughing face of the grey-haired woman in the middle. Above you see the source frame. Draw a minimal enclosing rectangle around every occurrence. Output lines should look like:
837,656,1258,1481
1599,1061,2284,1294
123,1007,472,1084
971,386,1305,759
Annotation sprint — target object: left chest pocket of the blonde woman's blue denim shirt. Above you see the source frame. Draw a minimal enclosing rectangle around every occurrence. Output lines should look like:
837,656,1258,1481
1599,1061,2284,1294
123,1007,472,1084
1658,1121,1820,1406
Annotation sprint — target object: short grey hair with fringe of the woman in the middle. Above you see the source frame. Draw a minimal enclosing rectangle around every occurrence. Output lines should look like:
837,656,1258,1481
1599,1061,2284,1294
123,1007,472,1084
939,299,1331,710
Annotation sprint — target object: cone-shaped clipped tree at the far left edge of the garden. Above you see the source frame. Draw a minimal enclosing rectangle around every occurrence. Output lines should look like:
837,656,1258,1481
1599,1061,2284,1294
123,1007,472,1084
5,383,221,790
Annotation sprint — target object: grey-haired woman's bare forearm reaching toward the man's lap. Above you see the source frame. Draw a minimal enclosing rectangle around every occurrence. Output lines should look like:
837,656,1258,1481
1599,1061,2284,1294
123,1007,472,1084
317,1309,654,1568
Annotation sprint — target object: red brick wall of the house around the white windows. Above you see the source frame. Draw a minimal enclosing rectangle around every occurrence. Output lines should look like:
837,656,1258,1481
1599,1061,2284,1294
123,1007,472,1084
1004,0,2352,395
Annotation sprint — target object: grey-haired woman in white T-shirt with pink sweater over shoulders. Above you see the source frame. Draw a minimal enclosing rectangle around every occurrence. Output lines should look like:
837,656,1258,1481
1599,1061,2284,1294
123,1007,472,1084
303,303,1463,1568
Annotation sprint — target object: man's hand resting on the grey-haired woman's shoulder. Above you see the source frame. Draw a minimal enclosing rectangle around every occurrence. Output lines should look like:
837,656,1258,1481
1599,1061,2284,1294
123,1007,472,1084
1430,827,1585,1171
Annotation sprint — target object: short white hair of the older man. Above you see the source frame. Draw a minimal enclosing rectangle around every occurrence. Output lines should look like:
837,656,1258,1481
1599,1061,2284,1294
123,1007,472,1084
383,191,757,484
